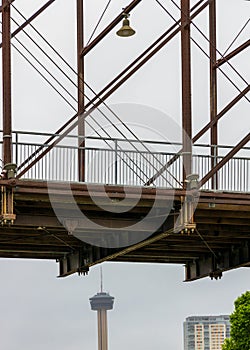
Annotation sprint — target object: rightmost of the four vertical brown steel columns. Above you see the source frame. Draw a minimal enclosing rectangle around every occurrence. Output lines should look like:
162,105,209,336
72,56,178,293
209,0,218,189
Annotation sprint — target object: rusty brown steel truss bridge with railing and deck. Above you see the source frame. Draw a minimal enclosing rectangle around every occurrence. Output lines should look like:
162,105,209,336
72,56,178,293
0,0,250,281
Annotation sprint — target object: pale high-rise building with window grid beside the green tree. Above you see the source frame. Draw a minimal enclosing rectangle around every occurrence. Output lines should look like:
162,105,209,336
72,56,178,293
183,315,230,350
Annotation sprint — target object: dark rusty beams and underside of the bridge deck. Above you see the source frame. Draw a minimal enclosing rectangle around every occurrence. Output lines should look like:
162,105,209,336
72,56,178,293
0,180,250,280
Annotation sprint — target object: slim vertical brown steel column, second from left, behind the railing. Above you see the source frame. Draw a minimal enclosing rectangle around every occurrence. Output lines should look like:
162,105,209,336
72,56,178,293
76,0,85,181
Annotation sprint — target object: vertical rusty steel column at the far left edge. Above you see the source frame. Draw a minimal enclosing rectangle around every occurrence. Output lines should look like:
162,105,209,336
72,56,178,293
2,0,12,165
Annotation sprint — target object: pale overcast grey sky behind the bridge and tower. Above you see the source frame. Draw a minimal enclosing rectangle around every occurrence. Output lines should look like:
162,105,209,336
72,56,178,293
0,0,250,350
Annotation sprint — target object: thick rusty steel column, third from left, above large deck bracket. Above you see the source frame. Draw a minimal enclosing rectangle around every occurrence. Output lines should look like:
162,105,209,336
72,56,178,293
181,0,192,187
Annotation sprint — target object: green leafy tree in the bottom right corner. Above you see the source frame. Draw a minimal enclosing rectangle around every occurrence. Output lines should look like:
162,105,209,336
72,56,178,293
222,291,250,350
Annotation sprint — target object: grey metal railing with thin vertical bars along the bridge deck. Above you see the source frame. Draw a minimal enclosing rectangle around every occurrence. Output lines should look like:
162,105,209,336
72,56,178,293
0,132,250,192
